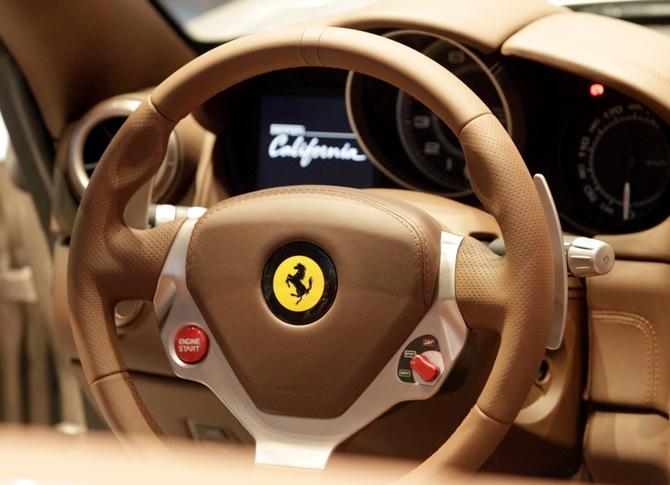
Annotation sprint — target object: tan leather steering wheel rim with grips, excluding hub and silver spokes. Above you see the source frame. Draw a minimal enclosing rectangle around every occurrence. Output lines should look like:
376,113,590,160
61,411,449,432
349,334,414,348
68,27,554,470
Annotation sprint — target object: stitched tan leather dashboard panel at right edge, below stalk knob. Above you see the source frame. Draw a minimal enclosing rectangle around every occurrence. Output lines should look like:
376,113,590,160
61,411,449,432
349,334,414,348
588,260,670,413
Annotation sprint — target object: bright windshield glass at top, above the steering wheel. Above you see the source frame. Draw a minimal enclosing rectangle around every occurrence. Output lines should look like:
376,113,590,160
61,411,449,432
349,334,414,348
158,0,656,44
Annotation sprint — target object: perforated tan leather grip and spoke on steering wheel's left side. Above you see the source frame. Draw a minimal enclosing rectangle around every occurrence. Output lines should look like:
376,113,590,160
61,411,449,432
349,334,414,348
68,104,185,430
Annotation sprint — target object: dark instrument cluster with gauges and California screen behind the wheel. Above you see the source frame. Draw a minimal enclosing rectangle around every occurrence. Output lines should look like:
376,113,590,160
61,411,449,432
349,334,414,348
209,30,670,235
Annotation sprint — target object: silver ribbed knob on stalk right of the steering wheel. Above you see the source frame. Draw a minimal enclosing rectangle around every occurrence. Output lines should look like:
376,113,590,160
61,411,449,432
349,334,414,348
564,237,614,278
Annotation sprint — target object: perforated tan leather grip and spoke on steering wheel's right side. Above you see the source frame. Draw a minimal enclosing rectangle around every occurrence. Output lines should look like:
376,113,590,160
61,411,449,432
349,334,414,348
456,115,554,423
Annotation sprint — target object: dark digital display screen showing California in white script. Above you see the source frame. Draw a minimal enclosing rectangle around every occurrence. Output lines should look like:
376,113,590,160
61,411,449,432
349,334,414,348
256,96,374,189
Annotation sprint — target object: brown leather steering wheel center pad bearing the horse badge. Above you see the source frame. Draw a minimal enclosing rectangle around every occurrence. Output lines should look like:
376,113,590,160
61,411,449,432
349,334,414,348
186,187,440,418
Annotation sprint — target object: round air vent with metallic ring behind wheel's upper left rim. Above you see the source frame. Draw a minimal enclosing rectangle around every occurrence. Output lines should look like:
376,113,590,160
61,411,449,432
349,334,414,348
68,96,181,200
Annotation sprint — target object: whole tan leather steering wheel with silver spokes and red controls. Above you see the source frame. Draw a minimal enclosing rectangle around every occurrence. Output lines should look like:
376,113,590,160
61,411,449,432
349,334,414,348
68,27,554,476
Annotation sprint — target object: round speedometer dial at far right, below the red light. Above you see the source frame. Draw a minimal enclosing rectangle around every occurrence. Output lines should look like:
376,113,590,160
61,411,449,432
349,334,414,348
573,102,670,228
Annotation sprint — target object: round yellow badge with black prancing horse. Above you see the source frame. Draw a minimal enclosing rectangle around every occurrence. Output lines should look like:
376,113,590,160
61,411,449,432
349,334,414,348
272,256,326,312
